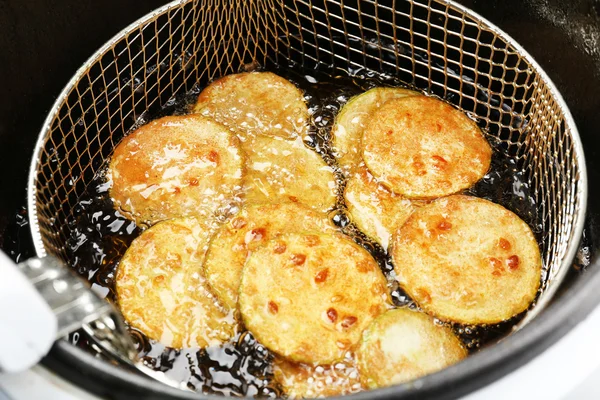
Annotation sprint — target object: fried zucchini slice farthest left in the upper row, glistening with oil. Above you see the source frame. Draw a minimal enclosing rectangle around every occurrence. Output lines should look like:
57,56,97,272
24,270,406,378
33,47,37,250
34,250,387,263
108,115,244,225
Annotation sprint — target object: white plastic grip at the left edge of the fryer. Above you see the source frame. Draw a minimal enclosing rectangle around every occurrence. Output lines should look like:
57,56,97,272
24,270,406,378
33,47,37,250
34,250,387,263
0,251,57,372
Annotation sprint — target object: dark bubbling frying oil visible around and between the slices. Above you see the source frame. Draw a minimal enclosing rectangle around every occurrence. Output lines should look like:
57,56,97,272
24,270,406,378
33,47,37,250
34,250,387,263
45,68,540,397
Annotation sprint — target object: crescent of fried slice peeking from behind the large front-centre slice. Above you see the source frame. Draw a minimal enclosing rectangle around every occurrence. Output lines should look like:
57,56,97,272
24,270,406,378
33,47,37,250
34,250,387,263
204,202,335,308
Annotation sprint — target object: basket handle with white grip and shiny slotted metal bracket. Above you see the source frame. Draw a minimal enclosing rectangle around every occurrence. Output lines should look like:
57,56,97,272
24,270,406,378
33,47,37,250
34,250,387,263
0,253,137,371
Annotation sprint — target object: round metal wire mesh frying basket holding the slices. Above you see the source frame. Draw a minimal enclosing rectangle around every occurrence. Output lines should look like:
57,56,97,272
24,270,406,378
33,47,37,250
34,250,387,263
29,0,587,322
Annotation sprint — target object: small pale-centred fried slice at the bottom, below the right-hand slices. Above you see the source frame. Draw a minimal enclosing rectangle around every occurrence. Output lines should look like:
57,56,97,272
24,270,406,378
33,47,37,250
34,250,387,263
356,308,467,389
